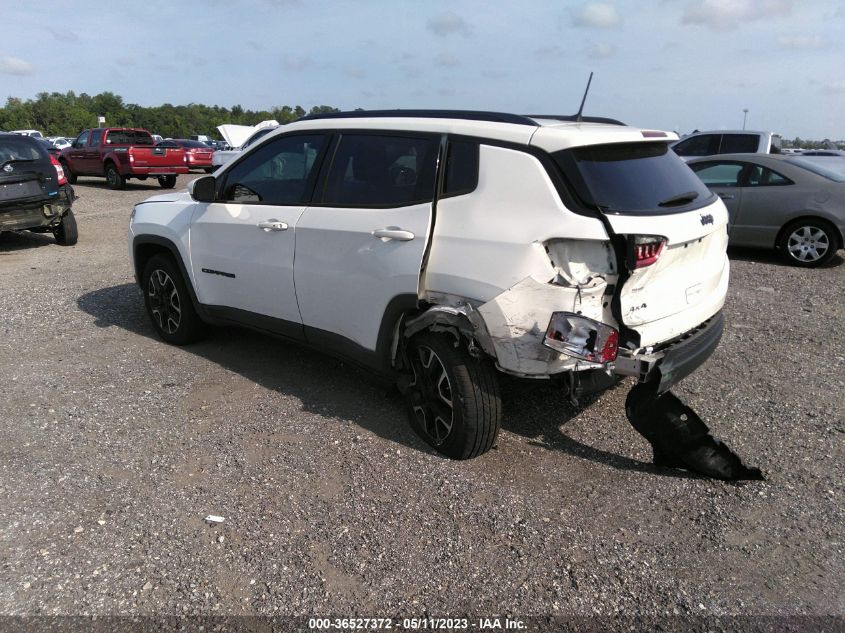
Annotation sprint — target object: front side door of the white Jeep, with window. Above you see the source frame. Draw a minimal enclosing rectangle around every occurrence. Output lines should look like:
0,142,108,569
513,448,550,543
190,134,326,336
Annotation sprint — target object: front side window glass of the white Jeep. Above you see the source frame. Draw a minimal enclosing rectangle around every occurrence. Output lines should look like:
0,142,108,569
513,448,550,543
222,134,326,205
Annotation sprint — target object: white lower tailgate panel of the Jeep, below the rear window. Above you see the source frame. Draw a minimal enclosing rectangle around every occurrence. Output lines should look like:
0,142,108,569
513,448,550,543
608,198,730,346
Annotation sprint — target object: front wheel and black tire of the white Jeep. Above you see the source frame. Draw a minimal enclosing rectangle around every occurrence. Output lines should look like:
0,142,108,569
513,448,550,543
141,254,205,345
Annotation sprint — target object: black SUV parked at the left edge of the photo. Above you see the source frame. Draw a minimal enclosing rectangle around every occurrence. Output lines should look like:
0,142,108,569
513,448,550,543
0,134,78,246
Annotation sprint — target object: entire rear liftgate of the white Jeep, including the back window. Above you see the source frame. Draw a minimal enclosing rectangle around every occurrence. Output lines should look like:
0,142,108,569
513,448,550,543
555,142,729,346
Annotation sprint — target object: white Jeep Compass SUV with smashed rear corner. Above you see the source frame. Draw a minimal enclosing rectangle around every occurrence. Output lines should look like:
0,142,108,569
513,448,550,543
129,110,728,458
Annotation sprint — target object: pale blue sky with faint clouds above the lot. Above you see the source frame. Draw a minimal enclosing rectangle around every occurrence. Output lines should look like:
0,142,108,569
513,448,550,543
0,0,845,139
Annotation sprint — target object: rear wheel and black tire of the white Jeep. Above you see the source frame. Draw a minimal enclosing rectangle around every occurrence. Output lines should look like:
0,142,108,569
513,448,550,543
405,333,502,459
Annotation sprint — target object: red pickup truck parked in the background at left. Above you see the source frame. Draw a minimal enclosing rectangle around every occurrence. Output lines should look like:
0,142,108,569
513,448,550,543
59,127,188,189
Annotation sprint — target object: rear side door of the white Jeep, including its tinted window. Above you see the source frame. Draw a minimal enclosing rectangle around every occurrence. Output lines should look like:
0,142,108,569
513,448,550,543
294,132,440,352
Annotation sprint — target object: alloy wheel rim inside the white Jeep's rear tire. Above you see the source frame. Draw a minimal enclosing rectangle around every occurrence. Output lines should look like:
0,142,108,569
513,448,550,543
409,345,455,446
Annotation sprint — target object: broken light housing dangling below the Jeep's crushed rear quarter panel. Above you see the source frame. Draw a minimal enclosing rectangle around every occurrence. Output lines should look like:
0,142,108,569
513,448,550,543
543,312,619,363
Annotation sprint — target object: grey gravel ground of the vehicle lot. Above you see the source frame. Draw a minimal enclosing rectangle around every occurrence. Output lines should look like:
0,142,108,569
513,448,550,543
0,176,845,618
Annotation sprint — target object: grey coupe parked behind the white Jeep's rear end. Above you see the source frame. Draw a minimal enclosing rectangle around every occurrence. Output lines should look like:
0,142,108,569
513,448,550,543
688,154,845,267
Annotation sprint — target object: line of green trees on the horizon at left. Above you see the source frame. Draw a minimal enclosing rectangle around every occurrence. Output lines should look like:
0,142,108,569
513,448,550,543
0,90,339,138
